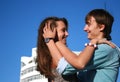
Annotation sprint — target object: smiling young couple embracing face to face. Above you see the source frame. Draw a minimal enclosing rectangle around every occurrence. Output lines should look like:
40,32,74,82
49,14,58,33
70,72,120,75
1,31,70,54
36,9,120,82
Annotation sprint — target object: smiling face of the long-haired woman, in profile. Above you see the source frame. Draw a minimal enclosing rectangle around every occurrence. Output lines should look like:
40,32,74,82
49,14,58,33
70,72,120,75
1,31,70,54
57,21,68,44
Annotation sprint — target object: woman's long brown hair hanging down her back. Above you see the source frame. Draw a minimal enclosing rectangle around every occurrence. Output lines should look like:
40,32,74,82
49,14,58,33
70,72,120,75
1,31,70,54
36,17,68,79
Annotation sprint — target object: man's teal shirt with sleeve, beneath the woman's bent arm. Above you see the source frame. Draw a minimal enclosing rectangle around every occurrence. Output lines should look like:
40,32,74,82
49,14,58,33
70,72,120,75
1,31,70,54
62,44,120,82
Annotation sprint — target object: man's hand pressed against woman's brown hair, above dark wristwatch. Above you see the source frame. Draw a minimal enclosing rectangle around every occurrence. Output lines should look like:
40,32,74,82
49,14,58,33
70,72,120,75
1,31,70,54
43,22,56,39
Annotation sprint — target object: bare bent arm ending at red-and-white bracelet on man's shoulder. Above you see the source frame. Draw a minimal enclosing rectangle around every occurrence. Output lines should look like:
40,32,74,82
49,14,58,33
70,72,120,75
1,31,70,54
56,41,95,69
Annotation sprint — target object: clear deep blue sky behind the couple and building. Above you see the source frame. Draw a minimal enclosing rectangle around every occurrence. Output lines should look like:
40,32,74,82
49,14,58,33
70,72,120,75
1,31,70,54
0,0,120,82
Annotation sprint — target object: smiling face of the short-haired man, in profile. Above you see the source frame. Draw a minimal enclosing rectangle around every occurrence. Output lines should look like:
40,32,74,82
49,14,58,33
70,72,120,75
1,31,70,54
84,17,101,40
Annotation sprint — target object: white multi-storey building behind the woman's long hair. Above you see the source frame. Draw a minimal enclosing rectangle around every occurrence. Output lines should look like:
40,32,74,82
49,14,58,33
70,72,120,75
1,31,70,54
20,48,48,82
